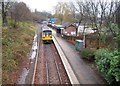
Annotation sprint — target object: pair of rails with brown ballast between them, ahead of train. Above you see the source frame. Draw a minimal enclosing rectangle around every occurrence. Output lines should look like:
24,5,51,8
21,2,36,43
45,44,63,84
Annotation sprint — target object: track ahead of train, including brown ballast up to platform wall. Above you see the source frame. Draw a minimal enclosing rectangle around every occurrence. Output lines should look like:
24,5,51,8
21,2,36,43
44,44,70,84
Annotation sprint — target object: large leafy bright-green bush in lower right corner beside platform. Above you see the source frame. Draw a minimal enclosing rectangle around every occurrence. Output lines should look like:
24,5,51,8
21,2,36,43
95,49,120,84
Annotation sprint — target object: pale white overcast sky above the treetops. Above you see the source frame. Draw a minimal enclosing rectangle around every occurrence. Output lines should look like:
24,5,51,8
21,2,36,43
19,0,73,13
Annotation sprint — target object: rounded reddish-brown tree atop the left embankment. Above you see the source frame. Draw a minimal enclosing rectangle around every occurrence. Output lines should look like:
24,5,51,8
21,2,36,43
9,2,32,28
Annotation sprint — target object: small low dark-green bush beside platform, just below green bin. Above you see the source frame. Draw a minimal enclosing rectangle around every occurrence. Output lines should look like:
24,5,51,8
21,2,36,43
81,48,94,60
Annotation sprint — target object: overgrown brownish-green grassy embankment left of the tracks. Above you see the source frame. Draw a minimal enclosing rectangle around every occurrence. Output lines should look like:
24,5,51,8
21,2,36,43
2,22,35,83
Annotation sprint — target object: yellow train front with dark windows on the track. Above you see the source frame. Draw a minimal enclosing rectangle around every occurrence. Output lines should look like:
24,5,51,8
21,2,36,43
42,29,53,43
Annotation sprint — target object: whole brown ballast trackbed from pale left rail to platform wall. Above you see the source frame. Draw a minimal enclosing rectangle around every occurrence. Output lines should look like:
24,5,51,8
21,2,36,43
32,32,71,85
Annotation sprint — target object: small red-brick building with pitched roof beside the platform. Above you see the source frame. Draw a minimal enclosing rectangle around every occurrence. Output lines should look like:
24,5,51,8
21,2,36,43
63,24,77,36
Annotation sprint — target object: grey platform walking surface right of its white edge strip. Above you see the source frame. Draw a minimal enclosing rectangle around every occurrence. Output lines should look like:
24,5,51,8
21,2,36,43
53,31,106,85
